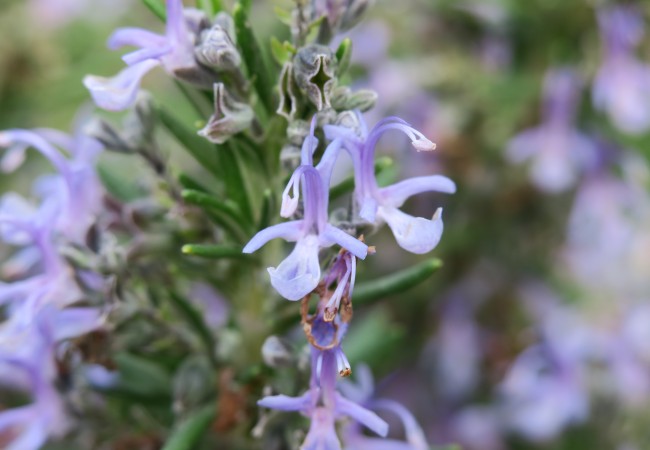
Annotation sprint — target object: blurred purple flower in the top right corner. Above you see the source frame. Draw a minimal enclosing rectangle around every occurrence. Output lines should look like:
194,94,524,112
592,6,650,133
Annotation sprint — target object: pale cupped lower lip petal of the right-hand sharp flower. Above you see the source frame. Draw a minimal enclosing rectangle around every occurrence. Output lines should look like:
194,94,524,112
379,207,443,255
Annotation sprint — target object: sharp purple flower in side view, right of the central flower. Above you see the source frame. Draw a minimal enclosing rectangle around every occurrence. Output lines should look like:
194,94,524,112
325,117,456,254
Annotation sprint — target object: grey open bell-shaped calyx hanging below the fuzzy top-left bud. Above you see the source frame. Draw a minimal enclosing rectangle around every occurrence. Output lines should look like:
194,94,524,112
199,83,254,144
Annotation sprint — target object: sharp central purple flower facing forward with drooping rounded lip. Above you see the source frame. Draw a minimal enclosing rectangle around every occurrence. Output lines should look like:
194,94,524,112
243,126,368,300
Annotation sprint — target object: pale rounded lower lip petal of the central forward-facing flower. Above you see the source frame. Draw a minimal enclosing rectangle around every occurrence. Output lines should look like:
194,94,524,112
268,235,320,300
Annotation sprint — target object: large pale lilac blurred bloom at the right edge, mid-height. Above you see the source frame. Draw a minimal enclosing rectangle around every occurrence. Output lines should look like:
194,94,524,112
564,167,650,301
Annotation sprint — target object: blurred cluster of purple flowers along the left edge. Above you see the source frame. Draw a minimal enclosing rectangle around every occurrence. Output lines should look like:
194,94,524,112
0,129,104,450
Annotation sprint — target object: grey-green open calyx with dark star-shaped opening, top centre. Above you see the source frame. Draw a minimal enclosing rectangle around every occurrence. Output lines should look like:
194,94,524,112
293,44,336,111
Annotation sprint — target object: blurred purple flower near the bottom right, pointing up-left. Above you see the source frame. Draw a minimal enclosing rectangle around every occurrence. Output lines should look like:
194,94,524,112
501,285,592,441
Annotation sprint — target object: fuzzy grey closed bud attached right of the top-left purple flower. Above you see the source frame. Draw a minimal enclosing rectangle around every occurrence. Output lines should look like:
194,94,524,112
194,13,241,71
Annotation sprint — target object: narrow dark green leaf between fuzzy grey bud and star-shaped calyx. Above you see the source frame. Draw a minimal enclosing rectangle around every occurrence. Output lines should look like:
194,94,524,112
232,0,276,114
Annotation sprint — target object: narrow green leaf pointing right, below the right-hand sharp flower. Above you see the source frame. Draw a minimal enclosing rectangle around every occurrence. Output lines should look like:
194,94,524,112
352,258,442,306
